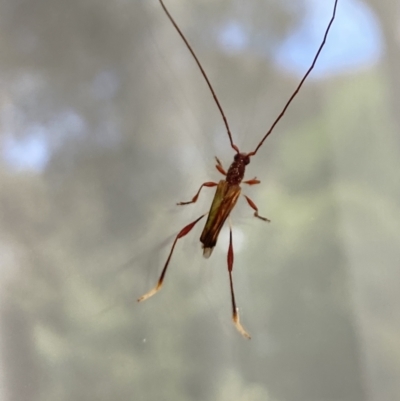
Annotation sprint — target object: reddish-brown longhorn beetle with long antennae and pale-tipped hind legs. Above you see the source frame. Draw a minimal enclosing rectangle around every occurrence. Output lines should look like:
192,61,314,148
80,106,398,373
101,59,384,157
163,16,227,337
138,0,338,338
